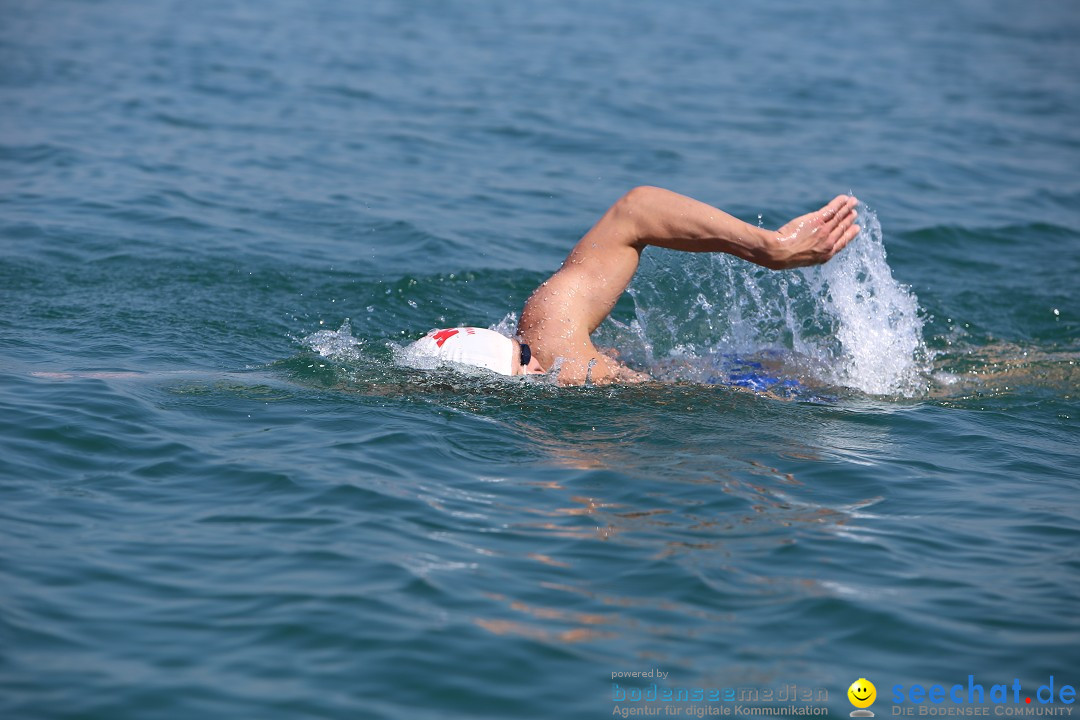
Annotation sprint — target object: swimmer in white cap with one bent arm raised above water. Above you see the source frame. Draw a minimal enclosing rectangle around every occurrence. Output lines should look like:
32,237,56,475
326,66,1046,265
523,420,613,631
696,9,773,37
409,187,860,385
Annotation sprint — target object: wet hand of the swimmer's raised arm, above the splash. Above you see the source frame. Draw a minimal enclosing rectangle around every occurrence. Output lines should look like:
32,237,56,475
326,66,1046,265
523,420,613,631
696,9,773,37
768,195,860,270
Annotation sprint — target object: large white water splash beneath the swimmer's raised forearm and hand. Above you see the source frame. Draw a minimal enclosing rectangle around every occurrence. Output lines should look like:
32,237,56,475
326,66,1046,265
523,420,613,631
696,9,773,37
613,207,929,396
